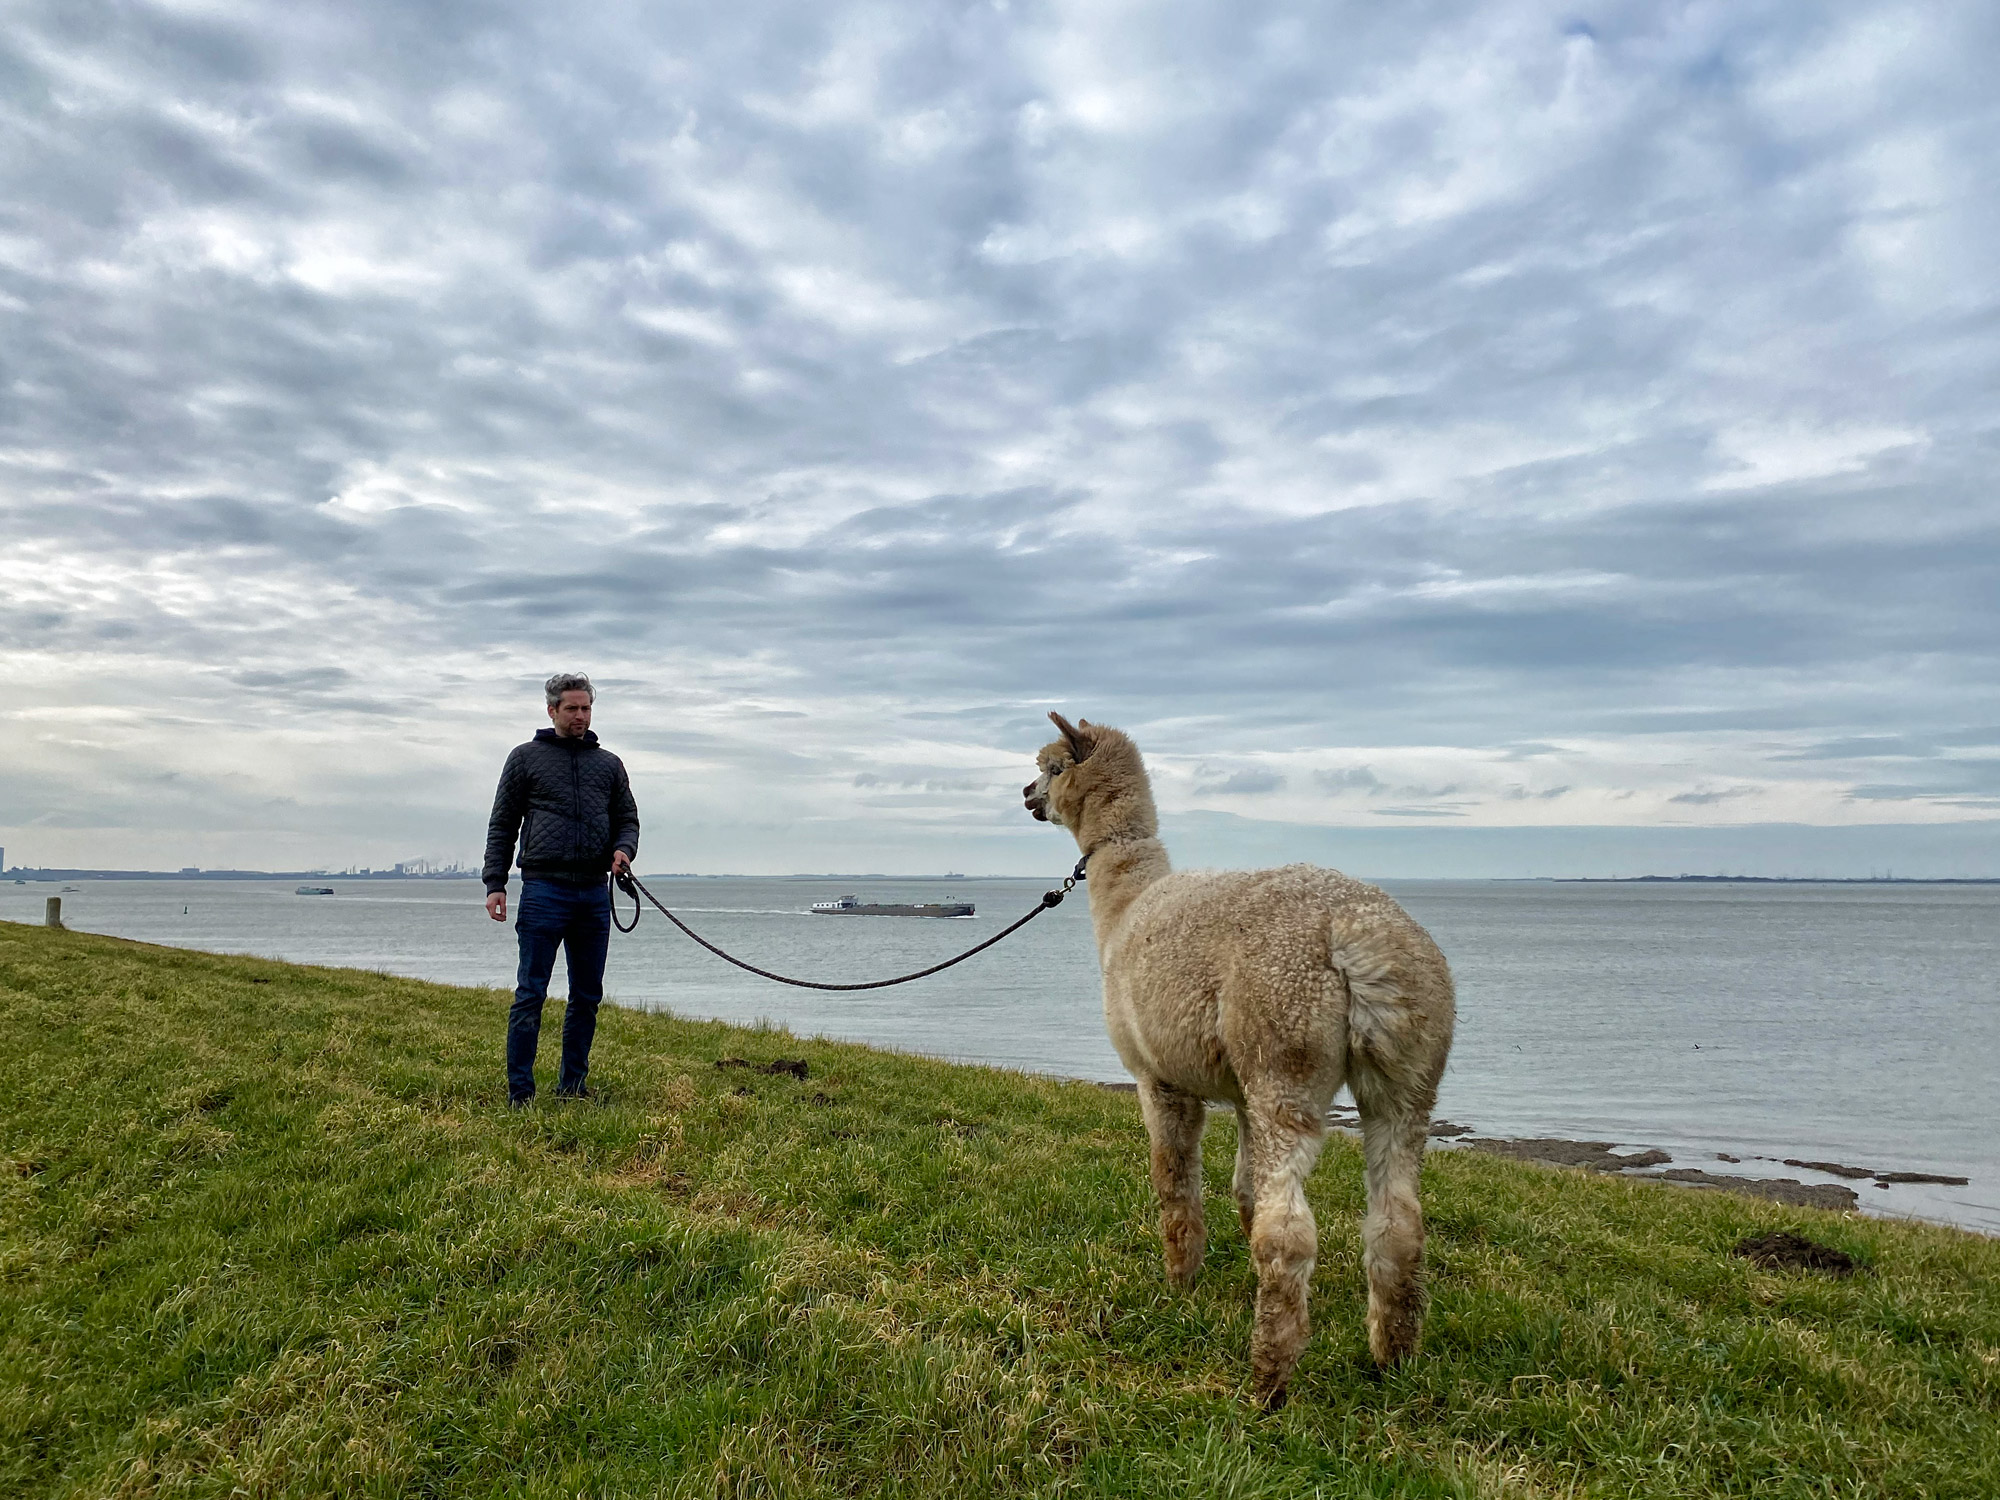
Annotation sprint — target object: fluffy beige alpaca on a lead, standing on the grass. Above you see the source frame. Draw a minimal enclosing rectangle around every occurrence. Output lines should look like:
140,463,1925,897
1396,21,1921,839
1022,714,1454,1406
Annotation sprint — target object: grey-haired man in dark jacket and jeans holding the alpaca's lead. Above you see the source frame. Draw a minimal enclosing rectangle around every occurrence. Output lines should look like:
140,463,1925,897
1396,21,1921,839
480,672,638,1108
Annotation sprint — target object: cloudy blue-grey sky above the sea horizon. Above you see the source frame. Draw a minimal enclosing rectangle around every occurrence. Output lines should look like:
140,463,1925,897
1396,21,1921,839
0,0,2000,874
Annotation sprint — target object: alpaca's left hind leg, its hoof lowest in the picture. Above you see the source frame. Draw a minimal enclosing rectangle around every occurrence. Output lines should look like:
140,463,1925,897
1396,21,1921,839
1246,1100,1326,1406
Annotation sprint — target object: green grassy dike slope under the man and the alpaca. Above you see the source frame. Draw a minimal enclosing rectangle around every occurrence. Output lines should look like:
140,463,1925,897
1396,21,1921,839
0,924,2000,1498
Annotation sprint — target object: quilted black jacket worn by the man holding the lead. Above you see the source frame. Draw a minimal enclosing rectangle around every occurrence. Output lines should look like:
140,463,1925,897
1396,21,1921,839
480,730,638,892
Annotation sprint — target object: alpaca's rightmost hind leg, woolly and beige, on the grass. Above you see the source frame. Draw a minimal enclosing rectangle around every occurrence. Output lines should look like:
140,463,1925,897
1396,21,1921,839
1350,1068,1430,1368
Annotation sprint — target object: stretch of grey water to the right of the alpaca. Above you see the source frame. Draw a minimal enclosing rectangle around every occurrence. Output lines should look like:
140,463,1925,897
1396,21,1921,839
1392,882,2000,1232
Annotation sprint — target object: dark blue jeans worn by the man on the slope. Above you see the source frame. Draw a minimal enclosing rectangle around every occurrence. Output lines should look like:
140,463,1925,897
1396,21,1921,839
506,880,612,1102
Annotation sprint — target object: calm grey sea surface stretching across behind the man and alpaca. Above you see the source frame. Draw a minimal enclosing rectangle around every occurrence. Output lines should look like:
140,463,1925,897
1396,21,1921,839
0,876,2000,1234
